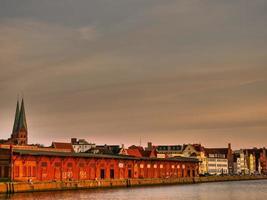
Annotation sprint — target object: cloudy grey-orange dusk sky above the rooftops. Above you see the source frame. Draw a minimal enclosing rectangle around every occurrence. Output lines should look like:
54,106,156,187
0,0,267,148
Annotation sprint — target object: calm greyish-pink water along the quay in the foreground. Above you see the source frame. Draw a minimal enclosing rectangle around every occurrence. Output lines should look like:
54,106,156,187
0,180,267,200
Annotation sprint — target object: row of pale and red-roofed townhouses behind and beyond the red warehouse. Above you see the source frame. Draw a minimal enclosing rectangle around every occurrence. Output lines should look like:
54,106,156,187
71,138,267,175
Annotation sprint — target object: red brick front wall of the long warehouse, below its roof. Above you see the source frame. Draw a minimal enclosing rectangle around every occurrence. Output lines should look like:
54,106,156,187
13,155,198,181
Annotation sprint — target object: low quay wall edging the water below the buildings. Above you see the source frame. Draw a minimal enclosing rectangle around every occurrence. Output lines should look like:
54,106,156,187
0,175,267,194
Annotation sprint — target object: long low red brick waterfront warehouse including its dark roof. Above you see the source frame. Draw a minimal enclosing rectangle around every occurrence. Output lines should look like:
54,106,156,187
0,149,198,181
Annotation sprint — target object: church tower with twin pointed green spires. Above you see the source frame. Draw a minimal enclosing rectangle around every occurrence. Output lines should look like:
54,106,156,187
10,99,28,145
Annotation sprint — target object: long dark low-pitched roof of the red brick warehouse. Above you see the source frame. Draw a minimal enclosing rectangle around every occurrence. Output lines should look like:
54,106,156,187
10,149,199,163
